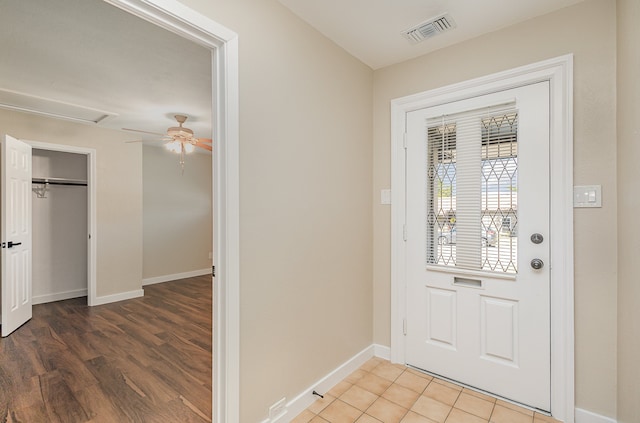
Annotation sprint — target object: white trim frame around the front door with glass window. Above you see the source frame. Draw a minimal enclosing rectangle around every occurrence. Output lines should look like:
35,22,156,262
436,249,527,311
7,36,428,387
391,54,575,422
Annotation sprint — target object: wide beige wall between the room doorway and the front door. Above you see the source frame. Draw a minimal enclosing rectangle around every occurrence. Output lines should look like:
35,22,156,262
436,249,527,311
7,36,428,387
175,0,372,423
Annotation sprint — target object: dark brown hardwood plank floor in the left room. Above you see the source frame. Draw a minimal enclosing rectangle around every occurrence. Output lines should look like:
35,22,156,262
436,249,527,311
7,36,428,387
0,276,212,423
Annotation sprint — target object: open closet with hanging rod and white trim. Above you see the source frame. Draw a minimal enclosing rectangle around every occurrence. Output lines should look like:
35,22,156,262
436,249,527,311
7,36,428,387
26,141,97,306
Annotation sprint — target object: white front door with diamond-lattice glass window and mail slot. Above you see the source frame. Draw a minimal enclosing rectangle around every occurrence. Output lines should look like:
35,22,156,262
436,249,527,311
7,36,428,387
405,82,551,411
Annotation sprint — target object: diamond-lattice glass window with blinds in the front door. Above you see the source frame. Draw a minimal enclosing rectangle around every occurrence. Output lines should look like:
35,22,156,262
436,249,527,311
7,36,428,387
426,104,518,274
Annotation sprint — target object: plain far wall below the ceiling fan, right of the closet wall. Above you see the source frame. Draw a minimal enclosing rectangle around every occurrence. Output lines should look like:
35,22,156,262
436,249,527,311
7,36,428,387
142,146,213,279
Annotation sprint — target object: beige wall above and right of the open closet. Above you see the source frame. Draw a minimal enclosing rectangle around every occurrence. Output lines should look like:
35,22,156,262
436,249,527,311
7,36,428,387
0,109,142,296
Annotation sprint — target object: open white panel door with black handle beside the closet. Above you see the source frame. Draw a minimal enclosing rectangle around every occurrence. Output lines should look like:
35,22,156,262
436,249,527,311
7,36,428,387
0,135,32,337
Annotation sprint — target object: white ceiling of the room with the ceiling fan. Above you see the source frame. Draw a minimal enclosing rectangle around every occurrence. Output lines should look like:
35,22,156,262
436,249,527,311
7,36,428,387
0,0,212,140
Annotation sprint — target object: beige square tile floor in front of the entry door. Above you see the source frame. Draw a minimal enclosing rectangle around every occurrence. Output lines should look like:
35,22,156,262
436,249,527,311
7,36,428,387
292,358,559,423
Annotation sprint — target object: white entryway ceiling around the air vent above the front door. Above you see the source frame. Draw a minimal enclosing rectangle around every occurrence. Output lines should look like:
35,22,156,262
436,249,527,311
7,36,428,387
279,0,583,69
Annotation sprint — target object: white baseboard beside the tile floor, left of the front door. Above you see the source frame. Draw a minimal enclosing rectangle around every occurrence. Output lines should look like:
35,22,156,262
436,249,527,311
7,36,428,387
262,344,390,423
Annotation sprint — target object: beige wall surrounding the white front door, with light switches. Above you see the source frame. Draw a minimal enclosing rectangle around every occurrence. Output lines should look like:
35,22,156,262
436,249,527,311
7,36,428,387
373,0,617,416
